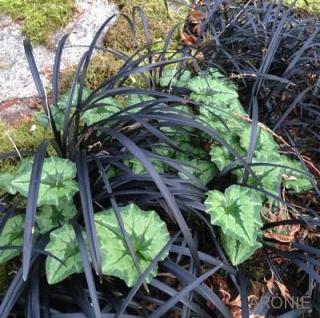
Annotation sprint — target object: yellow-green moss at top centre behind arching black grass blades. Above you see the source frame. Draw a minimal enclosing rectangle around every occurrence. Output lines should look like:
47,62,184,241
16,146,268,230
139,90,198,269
59,0,188,96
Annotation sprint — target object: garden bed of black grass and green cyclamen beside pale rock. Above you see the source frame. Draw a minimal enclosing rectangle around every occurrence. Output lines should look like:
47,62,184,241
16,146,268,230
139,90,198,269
0,1,320,318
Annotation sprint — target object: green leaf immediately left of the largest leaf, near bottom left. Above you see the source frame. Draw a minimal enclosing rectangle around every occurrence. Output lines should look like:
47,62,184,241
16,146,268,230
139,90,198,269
45,224,85,285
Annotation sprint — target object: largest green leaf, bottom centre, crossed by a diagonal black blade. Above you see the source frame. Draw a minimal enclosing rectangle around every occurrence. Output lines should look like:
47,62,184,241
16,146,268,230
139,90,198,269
95,204,169,287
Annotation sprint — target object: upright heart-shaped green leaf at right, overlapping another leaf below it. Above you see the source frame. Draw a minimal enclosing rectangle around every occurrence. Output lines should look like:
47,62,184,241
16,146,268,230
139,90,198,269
205,185,262,245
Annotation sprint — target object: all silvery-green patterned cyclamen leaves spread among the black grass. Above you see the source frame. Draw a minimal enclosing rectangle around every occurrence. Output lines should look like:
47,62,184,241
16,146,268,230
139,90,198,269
0,66,312,280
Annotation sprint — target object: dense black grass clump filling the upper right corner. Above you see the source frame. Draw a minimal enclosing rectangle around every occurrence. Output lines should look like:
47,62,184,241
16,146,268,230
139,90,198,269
191,1,320,164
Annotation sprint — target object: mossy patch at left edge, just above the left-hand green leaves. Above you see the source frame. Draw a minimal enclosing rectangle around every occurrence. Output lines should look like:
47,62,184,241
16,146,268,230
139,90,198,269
0,120,52,172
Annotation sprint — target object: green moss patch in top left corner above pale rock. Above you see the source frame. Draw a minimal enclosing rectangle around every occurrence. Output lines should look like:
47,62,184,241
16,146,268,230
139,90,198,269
0,0,75,46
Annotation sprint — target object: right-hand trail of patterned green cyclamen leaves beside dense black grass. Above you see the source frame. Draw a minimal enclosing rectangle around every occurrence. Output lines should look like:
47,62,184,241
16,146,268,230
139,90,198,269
160,69,313,265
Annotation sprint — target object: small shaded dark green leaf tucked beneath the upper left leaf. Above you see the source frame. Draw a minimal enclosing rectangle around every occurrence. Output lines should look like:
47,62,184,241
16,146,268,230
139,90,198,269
36,201,77,234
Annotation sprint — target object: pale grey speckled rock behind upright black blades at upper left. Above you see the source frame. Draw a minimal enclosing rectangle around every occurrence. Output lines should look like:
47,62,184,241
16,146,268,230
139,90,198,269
0,0,117,104
